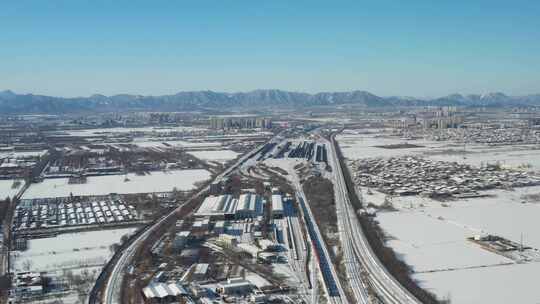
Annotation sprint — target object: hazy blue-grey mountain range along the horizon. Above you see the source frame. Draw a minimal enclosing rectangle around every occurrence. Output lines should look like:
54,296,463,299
0,90,540,114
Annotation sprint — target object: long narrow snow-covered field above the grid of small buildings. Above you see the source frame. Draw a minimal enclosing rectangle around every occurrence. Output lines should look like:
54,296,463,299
23,169,210,199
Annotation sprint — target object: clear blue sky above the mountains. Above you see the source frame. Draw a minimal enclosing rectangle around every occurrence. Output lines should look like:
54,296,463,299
0,0,540,97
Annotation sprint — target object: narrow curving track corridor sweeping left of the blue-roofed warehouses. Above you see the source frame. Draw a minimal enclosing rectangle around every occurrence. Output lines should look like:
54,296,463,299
93,144,272,304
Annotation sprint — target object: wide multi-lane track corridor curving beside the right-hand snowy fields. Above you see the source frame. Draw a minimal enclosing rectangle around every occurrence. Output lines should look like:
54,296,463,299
330,136,421,304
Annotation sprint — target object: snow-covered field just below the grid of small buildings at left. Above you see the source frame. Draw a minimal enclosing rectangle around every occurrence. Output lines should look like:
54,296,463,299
12,228,136,271
